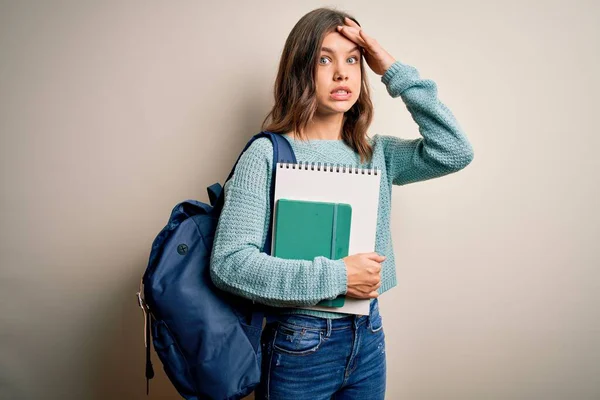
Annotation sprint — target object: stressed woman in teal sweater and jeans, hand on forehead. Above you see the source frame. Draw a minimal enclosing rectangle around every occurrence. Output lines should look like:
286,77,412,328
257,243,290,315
211,8,473,400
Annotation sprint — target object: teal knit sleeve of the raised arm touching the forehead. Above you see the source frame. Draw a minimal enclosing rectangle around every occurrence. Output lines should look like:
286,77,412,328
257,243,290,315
377,61,473,185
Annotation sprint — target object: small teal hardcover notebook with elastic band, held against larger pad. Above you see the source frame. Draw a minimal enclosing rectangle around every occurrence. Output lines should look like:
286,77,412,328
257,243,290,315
273,199,352,307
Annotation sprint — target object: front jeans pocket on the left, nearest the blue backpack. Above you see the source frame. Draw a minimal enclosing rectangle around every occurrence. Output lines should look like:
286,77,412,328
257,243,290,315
273,322,323,356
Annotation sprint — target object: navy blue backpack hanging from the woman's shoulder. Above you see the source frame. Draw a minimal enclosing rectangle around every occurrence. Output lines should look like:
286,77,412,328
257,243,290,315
137,131,296,400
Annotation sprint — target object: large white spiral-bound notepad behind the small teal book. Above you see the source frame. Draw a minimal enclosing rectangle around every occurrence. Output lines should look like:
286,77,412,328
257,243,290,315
272,162,381,315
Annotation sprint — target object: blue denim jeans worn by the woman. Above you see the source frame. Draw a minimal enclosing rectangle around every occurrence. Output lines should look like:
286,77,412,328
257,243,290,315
255,299,386,400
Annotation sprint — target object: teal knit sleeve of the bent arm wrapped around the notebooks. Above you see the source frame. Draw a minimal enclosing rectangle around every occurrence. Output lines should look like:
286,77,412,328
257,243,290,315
210,138,347,307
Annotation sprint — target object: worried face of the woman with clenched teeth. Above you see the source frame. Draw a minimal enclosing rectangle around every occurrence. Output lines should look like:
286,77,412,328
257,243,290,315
315,32,361,115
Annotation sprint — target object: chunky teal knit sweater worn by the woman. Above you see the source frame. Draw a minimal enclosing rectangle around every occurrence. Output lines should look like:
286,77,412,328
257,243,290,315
210,61,473,318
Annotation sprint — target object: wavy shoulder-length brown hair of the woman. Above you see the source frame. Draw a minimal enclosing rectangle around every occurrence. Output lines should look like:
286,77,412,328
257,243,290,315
261,8,373,162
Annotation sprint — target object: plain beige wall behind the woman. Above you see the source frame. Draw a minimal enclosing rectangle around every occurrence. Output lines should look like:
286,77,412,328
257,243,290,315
0,0,600,400
